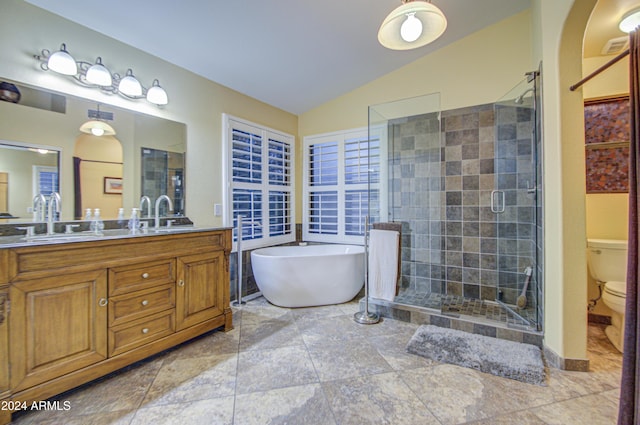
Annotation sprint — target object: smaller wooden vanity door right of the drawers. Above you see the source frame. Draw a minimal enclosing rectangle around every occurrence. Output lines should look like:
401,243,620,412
176,251,229,330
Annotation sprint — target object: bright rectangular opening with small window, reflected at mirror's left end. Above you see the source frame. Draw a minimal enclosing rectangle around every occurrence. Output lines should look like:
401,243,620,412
0,141,60,224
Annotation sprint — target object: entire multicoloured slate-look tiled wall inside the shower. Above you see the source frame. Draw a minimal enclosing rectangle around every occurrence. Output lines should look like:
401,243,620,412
389,104,536,322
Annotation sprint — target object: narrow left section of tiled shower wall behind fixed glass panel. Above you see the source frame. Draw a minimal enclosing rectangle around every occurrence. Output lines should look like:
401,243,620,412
389,114,445,293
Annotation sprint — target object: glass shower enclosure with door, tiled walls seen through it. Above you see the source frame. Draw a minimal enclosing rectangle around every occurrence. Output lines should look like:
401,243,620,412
369,71,543,331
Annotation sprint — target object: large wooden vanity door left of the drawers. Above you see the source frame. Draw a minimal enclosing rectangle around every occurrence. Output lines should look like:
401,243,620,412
9,270,107,392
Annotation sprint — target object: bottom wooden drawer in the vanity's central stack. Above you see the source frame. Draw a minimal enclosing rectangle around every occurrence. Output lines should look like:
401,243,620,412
109,310,175,357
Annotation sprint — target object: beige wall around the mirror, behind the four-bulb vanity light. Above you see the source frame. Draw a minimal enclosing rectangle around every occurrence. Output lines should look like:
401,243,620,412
0,0,298,225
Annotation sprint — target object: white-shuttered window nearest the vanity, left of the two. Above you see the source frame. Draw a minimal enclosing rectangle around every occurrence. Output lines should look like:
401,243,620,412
223,115,295,248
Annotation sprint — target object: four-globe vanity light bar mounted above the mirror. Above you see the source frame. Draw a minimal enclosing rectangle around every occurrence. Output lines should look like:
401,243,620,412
34,43,169,106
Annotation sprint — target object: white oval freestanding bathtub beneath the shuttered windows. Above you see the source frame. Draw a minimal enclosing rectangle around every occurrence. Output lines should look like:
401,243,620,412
251,245,364,307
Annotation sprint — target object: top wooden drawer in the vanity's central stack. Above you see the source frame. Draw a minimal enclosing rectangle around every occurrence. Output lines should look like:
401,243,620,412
109,259,176,296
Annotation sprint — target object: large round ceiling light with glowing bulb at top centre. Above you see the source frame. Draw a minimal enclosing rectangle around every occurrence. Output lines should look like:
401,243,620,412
378,0,447,50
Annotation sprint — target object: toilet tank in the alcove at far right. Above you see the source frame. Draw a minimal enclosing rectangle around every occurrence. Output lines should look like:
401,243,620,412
587,239,627,282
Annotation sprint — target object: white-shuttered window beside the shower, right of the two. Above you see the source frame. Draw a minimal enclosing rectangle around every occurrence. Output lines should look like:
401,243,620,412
303,129,381,244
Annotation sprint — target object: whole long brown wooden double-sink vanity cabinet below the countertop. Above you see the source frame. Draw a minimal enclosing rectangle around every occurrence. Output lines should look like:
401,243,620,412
0,229,232,425
